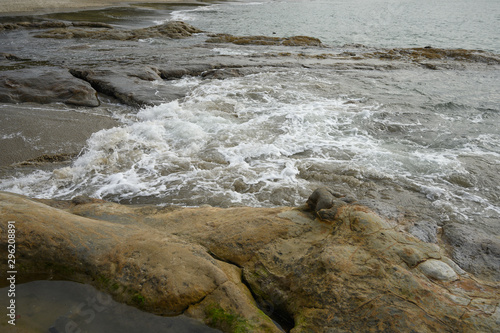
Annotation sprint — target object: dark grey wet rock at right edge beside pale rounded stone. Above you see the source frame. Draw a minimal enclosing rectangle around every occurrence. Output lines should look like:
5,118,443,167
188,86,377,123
443,223,500,281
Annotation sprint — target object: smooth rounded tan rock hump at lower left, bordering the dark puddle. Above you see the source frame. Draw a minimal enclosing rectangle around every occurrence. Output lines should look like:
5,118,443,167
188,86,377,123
0,193,279,332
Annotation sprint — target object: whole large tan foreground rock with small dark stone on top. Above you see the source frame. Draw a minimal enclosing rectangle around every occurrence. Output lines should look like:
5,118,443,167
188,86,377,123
0,189,500,333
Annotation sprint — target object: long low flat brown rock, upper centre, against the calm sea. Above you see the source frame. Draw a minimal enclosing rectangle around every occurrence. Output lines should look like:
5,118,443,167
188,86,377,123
207,34,322,46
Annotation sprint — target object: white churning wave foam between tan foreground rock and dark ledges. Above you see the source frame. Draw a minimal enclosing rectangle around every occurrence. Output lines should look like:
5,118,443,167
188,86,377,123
0,70,499,226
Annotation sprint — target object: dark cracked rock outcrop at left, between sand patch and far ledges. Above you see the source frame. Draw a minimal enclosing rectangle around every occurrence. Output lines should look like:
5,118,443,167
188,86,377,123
0,61,242,107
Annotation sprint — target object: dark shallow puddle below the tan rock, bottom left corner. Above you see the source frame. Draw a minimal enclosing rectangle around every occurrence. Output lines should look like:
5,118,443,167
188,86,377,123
0,281,220,333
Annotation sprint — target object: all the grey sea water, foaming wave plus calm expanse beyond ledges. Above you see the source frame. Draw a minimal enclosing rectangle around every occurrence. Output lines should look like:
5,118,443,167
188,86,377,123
0,0,500,234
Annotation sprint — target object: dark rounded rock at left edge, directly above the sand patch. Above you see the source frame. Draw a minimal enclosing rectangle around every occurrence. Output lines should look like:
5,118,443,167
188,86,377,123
0,67,99,107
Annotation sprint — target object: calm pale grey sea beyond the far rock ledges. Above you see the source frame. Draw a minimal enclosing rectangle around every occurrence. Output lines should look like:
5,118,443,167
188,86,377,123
172,0,500,52
